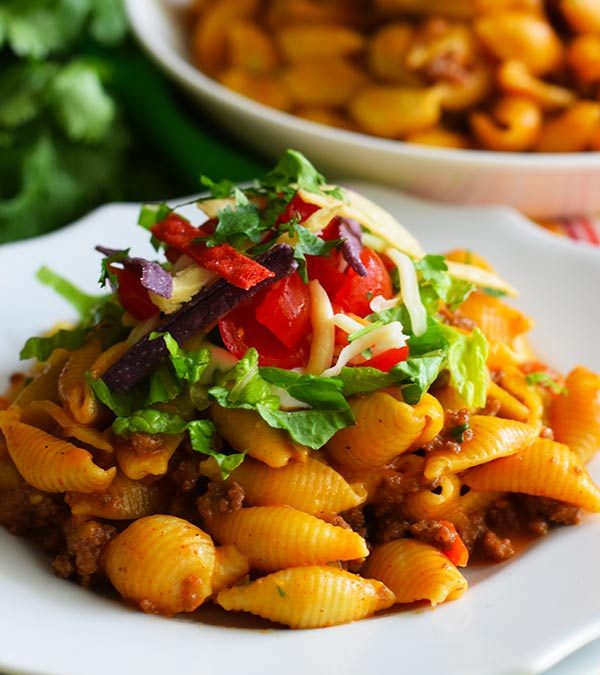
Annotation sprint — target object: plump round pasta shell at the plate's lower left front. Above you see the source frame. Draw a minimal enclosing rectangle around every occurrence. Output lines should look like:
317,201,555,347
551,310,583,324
104,515,215,616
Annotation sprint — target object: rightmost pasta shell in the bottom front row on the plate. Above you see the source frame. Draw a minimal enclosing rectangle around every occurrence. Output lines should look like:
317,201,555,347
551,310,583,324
363,539,468,605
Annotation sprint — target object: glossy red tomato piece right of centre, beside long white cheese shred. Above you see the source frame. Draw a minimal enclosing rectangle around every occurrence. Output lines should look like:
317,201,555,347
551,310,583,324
332,248,393,316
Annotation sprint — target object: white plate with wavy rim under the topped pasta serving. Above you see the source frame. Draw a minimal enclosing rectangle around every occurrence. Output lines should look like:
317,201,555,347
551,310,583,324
0,186,600,675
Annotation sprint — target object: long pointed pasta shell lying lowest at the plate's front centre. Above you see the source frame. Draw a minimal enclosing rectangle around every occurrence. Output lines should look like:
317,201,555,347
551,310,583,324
217,566,394,628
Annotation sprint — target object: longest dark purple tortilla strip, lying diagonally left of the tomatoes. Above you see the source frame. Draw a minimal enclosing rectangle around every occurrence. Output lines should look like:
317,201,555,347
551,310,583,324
102,244,298,393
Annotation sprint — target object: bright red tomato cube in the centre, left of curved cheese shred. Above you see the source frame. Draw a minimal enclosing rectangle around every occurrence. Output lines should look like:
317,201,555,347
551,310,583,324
256,273,310,349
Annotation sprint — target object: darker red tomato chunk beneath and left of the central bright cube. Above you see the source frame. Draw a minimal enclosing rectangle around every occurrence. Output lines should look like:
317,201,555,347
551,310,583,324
219,294,310,368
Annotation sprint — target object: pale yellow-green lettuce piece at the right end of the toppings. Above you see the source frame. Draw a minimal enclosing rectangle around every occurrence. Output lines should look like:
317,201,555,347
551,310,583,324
441,325,489,407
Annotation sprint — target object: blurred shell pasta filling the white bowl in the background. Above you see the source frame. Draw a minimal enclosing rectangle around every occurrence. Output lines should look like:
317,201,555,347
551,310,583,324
183,0,600,152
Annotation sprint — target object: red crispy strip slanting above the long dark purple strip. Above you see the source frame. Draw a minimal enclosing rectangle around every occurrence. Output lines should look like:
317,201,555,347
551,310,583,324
152,213,274,290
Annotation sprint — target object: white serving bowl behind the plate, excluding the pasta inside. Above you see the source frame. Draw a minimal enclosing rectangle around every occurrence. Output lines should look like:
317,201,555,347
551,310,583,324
126,0,600,217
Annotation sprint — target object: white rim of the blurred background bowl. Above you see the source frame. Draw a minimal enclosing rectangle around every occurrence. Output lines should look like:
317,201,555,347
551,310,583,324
125,0,600,172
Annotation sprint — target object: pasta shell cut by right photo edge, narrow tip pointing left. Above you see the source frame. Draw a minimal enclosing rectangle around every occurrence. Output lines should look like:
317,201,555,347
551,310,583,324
461,439,600,512
